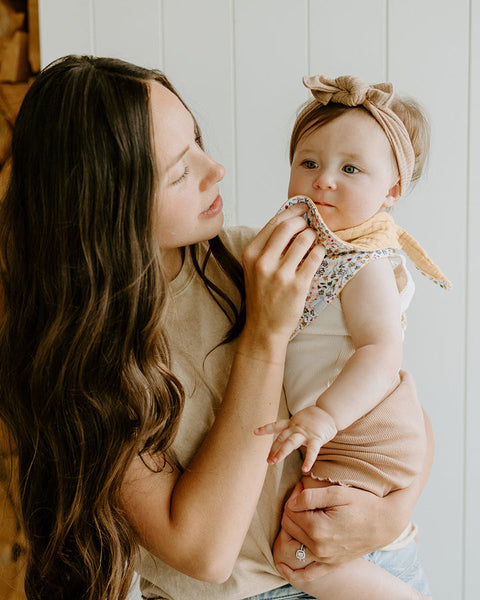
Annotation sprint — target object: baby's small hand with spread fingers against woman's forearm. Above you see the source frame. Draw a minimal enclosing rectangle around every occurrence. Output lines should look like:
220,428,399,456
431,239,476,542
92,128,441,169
254,406,337,473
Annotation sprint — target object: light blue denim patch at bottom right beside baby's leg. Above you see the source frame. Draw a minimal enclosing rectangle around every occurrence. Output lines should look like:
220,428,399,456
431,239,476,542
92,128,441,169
364,540,432,596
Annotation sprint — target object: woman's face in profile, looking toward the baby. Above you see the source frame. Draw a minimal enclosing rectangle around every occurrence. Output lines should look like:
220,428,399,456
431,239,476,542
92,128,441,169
150,82,225,276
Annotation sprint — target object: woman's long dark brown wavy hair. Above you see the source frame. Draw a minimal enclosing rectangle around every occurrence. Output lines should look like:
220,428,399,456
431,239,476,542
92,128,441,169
0,56,244,600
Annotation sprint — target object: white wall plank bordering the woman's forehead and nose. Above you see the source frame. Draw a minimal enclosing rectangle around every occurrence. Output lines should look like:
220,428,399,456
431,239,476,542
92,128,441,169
163,0,235,221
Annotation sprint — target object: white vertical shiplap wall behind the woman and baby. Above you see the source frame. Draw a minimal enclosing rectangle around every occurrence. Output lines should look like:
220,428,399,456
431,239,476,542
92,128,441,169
36,0,480,600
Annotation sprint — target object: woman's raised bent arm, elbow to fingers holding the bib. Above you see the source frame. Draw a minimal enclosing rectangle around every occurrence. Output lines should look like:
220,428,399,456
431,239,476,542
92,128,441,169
121,206,324,583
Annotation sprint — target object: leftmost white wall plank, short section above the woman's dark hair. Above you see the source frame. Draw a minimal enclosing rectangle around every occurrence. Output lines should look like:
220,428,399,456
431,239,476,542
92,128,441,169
38,0,95,66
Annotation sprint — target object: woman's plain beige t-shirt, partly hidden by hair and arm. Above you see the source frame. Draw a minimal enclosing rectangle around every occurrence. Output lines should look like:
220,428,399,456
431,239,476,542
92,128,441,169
136,227,301,600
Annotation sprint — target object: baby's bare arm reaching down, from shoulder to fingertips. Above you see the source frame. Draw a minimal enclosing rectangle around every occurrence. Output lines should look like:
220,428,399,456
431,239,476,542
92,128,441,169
255,259,402,471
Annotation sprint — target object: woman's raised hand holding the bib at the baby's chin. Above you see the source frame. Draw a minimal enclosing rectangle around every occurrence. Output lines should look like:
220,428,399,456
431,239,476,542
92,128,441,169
242,204,325,350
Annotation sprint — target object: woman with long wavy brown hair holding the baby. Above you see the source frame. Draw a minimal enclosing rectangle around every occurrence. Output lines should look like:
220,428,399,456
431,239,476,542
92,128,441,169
0,57,428,600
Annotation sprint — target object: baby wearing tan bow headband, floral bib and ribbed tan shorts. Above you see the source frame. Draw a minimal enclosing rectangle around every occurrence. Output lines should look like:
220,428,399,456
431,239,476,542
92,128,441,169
255,76,451,600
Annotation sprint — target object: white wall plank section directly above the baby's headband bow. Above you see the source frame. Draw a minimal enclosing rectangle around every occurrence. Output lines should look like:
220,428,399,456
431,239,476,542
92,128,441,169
310,0,386,83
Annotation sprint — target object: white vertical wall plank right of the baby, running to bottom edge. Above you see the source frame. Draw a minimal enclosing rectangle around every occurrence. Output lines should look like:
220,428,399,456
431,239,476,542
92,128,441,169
388,0,468,600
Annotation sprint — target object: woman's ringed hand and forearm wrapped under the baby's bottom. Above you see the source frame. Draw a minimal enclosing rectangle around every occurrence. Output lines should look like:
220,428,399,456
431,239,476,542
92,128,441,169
276,413,434,584
